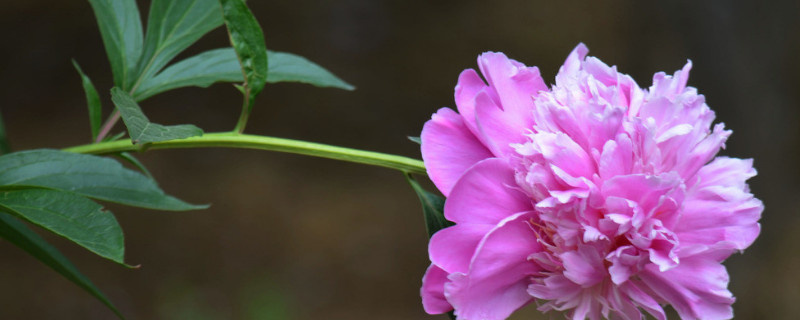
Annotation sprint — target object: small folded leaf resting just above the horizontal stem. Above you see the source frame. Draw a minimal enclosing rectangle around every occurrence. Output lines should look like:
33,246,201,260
111,87,203,144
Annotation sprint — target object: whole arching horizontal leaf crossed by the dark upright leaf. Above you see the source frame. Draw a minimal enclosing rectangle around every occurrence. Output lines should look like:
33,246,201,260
134,48,354,101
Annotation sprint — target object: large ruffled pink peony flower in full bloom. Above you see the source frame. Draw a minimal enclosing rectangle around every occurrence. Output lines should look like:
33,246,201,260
421,44,764,320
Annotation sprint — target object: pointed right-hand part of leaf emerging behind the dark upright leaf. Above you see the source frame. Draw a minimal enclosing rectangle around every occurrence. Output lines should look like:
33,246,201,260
267,51,355,90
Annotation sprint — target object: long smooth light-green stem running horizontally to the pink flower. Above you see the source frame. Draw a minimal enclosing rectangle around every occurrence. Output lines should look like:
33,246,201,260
64,132,426,174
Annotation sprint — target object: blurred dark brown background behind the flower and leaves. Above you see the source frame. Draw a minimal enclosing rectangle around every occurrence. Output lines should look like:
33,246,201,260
0,0,800,320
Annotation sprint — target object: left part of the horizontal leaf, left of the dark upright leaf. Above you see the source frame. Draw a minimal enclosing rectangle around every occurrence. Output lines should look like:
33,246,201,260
134,48,244,101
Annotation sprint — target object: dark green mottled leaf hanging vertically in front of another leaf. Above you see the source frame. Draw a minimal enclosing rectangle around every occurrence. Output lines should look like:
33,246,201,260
219,0,269,114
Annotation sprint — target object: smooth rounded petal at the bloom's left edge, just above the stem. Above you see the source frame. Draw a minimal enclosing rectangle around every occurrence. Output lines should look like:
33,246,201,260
420,108,492,196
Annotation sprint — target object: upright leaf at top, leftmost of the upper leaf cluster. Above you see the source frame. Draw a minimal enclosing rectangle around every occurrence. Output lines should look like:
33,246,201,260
89,0,142,90
